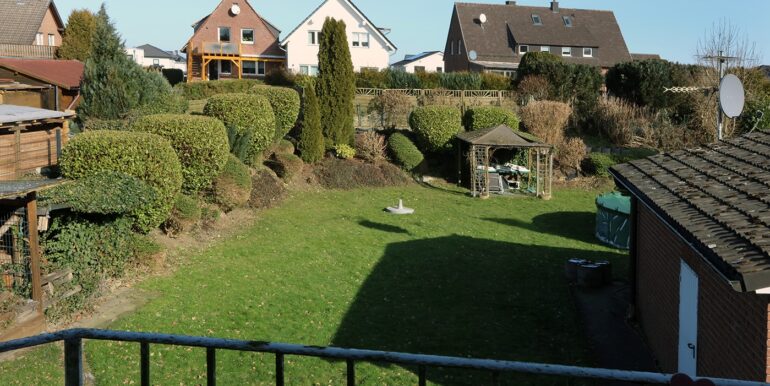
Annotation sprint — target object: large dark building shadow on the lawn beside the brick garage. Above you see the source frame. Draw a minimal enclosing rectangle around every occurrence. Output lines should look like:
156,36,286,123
332,236,623,385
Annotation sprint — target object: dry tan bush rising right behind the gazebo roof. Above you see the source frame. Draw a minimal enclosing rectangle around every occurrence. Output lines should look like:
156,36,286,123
521,101,572,145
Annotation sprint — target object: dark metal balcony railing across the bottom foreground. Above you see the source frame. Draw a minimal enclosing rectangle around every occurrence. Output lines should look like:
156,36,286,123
0,329,768,386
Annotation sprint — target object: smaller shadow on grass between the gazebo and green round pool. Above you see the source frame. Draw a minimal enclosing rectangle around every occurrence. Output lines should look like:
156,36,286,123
484,212,599,243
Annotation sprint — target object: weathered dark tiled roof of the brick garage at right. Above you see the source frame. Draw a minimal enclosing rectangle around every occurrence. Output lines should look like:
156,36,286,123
611,132,770,291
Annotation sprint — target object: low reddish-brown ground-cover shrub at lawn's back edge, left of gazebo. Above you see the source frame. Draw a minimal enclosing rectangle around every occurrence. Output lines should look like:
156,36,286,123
313,158,410,190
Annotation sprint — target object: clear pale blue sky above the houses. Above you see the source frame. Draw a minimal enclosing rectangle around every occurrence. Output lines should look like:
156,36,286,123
56,0,770,64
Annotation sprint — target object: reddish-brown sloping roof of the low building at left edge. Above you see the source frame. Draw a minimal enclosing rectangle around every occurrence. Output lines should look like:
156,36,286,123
0,58,85,89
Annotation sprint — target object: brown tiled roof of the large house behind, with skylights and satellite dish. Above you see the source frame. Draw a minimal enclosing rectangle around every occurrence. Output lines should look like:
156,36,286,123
455,3,631,67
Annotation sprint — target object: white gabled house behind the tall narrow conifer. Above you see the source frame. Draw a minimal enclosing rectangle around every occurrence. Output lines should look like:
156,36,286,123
281,0,397,75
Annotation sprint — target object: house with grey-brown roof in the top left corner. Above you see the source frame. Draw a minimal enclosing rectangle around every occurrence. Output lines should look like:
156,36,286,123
0,0,64,59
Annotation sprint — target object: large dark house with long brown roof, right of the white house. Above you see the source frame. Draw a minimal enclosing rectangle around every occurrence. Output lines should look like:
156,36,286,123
444,0,631,76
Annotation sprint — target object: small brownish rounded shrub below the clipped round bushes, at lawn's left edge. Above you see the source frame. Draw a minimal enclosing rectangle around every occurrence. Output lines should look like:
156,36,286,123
213,155,252,212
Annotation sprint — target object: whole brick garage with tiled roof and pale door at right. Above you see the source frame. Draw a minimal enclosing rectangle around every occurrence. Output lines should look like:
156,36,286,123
611,132,770,382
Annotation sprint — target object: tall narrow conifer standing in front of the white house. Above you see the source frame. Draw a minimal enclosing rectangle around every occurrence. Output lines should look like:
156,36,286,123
316,18,356,147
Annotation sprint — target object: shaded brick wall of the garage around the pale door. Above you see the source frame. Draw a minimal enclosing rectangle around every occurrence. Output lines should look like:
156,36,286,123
635,205,770,381
